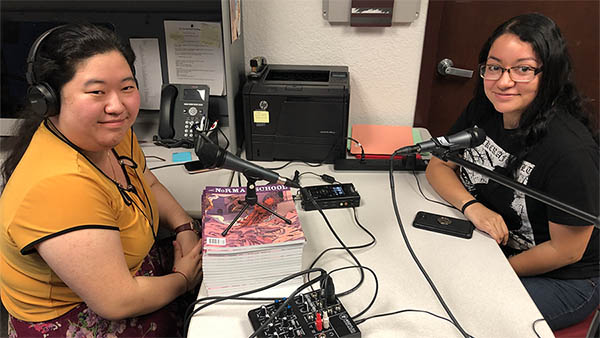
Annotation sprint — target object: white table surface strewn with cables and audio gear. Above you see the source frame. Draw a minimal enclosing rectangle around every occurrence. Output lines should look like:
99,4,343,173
143,146,553,338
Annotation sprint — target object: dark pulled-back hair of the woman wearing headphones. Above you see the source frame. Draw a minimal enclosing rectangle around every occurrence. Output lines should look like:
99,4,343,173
1,23,135,184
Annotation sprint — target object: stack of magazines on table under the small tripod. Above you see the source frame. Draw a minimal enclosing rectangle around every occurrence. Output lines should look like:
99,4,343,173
202,184,306,296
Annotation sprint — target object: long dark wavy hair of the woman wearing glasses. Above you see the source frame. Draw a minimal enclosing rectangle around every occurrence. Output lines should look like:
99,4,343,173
475,13,598,175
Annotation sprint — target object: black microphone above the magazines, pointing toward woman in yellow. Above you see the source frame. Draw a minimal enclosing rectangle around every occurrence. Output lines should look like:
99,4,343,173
195,139,301,189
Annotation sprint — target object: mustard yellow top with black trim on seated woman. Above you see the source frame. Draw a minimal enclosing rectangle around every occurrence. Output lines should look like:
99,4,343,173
0,123,158,322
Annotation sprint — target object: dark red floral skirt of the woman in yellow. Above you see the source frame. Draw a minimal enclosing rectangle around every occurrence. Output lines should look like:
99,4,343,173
8,241,196,338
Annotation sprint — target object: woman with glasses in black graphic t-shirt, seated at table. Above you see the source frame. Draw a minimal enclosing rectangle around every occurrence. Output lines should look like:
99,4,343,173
426,14,599,330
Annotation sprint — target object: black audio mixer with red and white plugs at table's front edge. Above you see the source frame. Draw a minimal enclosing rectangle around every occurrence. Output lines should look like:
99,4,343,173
248,291,361,338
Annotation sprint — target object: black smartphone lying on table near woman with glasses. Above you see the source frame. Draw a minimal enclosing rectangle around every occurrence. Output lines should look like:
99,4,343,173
413,211,475,238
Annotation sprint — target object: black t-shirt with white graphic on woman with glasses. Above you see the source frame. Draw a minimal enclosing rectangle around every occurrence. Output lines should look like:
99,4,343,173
449,100,600,279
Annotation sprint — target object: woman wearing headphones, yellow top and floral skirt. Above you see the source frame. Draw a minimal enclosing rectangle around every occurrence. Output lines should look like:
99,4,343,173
0,24,202,337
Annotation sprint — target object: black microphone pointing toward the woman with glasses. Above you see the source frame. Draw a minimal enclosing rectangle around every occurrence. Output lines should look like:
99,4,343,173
397,127,485,155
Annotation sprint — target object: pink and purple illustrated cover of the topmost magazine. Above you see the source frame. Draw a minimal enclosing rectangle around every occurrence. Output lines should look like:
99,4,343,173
202,184,305,252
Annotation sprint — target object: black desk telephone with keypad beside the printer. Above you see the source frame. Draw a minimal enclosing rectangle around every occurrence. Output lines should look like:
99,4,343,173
156,84,210,148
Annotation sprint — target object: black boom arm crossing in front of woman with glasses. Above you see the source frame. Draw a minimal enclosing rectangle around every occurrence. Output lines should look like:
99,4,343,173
432,151,600,228
